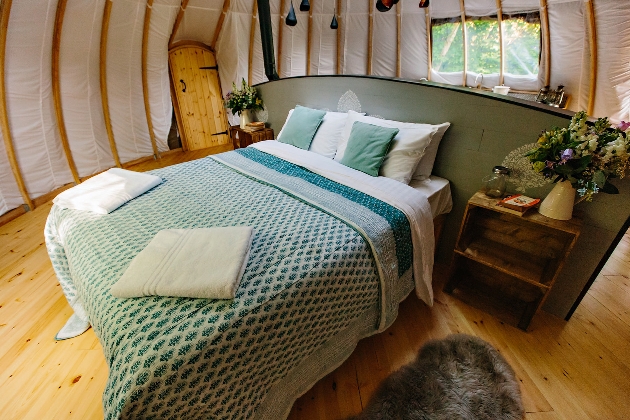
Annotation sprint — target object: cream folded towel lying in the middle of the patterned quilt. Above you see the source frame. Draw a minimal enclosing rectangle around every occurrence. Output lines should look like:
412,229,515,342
111,226,254,299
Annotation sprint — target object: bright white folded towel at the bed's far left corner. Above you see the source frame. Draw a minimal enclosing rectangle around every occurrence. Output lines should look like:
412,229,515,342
53,168,162,214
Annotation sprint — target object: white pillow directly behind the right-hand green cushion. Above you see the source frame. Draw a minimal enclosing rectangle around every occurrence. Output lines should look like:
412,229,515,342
335,111,444,184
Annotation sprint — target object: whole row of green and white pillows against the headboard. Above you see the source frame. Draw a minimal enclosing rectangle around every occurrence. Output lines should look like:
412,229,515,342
278,105,450,184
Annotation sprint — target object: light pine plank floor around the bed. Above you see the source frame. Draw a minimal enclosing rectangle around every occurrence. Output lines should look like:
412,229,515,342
0,147,630,420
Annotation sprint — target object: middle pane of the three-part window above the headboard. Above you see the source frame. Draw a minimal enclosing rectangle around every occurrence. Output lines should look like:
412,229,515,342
466,18,501,74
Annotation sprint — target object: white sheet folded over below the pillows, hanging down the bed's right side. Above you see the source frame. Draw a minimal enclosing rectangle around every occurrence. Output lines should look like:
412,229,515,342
249,140,435,306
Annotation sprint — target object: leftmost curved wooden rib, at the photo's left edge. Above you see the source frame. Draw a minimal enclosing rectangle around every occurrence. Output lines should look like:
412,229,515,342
0,0,35,210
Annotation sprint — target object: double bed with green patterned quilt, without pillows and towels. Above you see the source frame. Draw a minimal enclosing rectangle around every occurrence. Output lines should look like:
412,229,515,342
45,141,451,419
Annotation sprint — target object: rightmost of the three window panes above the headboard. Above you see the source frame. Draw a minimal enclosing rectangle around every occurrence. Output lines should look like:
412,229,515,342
503,12,541,76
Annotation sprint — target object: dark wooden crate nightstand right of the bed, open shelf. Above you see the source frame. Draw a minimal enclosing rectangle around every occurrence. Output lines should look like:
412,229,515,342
444,192,581,331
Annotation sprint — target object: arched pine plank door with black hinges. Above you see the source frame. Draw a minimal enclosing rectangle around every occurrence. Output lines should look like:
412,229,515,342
168,41,230,150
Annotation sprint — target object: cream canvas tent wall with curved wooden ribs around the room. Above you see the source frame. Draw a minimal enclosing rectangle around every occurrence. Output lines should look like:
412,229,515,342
0,0,630,218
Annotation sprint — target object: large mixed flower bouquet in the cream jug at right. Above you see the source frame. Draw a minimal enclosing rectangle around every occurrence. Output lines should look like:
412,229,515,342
525,111,630,201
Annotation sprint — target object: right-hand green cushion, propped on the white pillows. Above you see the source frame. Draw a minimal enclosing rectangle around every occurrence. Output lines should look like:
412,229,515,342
341,121,398,176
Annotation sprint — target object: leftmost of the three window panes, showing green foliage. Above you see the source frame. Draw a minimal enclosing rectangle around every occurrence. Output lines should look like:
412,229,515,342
431,18,464,72
